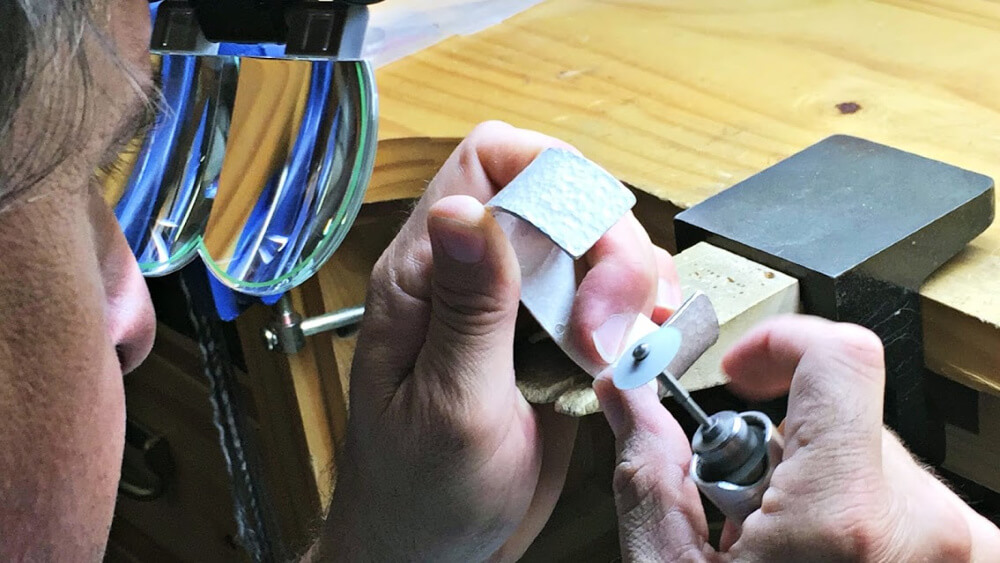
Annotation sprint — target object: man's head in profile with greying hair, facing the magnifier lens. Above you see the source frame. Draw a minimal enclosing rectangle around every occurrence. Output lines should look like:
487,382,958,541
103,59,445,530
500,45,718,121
0,0,154,560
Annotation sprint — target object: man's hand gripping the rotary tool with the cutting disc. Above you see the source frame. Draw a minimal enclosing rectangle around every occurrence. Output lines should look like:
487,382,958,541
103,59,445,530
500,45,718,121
595,317,1000,562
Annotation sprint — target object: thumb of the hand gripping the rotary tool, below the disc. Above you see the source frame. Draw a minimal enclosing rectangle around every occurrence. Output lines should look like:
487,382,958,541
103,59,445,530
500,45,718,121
594,375,712,561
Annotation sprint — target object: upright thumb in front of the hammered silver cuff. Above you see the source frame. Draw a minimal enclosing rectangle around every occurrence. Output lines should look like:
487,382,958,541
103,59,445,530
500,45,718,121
416,195,521,400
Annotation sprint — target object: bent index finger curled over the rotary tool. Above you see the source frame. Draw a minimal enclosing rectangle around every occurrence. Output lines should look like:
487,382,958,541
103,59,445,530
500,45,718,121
722,316,885,467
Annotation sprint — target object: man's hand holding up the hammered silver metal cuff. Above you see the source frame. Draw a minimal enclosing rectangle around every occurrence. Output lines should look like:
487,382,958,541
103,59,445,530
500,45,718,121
320,123,680,561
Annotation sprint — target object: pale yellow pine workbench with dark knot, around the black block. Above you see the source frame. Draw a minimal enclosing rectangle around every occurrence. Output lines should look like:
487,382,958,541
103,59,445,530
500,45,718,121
369,0,1000,393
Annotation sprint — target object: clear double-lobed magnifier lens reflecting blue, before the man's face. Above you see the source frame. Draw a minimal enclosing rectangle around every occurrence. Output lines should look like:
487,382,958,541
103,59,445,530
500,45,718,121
108,55,378,296
